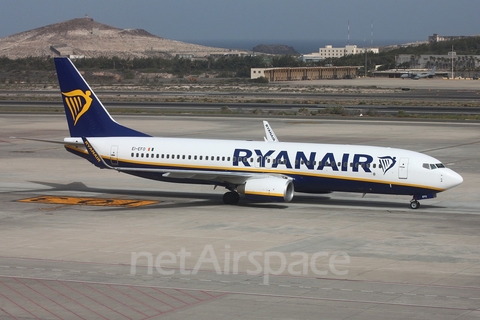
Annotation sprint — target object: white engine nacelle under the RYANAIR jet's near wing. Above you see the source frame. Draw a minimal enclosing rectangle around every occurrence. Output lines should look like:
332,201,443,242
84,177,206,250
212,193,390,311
237,177,293,202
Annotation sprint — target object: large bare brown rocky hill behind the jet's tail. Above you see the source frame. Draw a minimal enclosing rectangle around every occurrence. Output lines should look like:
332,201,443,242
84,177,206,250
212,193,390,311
0,16,229,59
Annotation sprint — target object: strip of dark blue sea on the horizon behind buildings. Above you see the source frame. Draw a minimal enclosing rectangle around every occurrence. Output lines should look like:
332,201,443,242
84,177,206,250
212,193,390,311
180,39,418,54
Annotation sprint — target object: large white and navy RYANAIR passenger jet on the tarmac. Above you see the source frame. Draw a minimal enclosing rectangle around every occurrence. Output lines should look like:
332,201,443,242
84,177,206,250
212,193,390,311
41,57,463,209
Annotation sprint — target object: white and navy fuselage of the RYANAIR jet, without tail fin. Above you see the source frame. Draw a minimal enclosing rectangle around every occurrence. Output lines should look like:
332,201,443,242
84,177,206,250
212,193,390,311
67,137,463,195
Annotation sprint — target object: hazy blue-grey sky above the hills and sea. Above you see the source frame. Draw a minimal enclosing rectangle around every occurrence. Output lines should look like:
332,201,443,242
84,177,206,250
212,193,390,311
0,0,480,45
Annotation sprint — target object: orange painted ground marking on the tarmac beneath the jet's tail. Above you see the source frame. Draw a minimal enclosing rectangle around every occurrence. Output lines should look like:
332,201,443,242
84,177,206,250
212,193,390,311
18,196,159,208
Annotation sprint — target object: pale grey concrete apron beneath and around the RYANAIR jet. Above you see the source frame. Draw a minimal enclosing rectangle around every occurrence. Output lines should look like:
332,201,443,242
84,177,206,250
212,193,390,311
0,114,480,319
